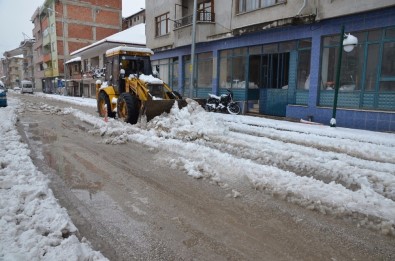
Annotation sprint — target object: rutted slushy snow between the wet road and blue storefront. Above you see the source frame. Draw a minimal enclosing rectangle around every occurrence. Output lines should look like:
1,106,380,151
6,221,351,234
35,93,395,235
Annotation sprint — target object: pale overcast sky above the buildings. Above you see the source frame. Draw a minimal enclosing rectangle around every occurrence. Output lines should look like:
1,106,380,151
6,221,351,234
0,0,145,57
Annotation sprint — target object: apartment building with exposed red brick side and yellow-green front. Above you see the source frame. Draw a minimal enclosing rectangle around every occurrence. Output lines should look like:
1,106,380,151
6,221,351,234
31,0,122,93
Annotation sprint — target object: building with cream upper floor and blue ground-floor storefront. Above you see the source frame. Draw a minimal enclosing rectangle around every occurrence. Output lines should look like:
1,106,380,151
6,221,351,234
146,0,395,132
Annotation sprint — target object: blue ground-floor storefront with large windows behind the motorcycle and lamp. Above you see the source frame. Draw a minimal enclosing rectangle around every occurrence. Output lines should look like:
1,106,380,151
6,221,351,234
153,8,395,132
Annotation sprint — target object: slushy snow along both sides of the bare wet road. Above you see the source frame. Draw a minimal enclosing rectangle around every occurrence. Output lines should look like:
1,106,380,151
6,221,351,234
0,90,395,259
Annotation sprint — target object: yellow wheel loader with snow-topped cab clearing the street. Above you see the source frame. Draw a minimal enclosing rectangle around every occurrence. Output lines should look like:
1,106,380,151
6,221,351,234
96,46,204,124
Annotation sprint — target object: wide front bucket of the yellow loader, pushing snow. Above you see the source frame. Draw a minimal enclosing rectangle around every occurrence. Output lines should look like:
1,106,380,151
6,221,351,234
142,99,206,121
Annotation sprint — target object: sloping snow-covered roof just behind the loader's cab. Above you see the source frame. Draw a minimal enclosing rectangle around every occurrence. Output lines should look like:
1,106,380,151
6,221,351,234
70,24,146,55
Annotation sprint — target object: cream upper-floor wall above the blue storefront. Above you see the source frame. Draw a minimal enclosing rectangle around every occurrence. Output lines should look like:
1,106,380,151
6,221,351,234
146,0,395,50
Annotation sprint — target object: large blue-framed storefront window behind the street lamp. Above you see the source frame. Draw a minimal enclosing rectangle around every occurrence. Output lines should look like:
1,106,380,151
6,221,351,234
319,28,395,110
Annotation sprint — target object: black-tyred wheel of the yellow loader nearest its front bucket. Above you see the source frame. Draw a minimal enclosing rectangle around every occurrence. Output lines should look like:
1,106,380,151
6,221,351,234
117,93,140,124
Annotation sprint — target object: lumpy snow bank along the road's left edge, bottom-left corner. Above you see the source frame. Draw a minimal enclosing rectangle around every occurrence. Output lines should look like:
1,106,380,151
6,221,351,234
0,99,107,260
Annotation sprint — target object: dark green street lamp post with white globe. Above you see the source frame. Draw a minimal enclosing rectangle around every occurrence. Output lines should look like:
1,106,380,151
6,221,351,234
329,25,358,127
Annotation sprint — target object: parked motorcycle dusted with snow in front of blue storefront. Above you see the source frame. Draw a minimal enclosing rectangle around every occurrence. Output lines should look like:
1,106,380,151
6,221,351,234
205,89,241,114
